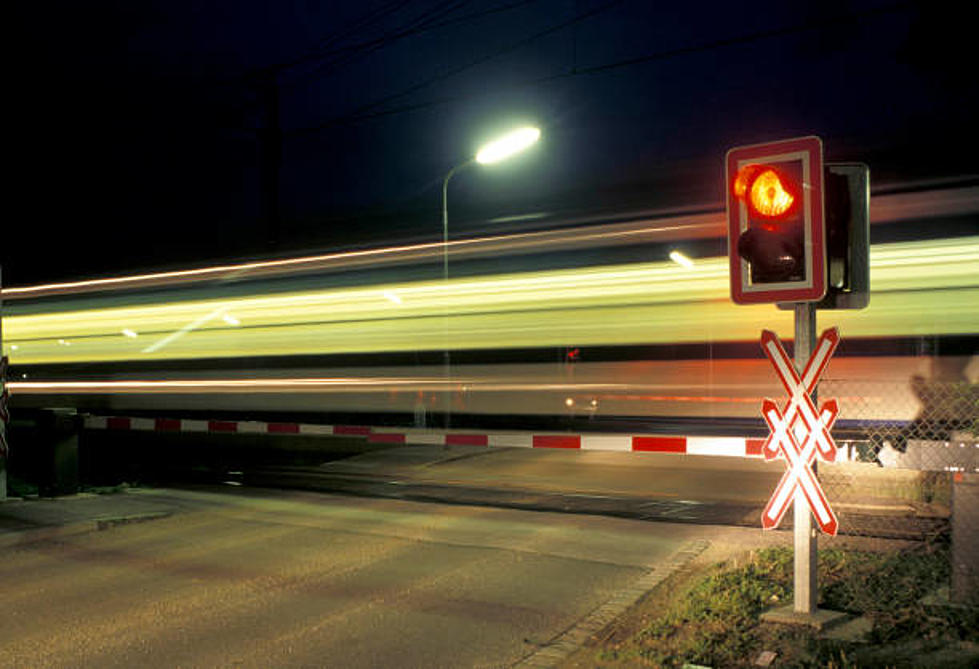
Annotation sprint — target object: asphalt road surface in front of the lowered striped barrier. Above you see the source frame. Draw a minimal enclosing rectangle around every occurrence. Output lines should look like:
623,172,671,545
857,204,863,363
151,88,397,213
0,490,758,667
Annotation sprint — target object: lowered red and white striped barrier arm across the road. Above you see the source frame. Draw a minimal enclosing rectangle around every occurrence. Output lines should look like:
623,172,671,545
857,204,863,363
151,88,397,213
85,416,765,457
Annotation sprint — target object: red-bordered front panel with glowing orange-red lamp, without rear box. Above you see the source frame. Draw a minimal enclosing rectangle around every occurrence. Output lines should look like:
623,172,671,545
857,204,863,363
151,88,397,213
726,137,826,304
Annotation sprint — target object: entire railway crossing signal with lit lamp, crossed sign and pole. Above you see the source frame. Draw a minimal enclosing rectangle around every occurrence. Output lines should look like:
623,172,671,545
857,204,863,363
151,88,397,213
725,137,870,622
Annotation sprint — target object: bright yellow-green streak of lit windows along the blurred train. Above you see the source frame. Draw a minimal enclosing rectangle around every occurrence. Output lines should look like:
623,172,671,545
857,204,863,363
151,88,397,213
4,237,979,368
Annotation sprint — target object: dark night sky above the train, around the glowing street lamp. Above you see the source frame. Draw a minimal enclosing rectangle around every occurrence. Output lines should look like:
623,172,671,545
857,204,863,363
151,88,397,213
0,0,979,285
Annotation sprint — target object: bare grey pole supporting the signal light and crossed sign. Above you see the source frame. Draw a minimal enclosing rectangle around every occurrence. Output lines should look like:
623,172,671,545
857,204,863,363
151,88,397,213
789,302,819,614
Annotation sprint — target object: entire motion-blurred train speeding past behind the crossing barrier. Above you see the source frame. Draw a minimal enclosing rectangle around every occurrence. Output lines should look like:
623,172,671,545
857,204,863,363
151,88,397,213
3,180,979,436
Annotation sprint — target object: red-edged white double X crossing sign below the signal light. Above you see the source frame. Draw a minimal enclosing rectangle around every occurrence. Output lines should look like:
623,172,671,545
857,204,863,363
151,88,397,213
761,328,840,535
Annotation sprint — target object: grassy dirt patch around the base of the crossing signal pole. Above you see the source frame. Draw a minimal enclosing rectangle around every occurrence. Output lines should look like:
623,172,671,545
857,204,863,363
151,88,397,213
568,542,979,669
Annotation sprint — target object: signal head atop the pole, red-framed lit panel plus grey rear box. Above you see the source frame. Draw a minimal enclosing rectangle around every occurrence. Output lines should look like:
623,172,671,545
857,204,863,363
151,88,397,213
726,137,870,309
